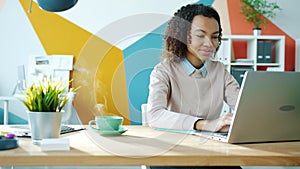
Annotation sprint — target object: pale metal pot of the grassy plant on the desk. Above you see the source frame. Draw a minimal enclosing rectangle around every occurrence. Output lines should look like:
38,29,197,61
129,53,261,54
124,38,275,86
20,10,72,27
27,111,62,145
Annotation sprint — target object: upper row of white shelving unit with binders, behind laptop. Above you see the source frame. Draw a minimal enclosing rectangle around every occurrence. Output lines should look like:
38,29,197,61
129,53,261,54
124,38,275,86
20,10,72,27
216,35,285,72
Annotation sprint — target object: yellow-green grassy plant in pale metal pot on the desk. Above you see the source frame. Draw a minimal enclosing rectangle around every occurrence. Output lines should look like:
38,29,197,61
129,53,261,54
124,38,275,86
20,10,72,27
21,77,76,144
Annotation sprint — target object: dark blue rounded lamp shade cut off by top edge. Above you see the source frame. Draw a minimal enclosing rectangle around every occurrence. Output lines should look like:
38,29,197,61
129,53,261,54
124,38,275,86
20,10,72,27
28,0,78,13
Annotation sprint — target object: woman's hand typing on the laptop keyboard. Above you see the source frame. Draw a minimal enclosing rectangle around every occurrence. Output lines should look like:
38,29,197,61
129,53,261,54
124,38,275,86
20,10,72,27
196,112,232,132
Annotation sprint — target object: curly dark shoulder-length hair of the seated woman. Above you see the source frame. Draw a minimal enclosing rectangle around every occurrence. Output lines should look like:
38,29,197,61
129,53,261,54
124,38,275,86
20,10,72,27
162,4,222,59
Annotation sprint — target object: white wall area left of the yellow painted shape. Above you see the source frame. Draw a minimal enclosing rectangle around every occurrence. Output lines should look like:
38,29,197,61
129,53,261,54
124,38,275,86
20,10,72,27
0,0,45,118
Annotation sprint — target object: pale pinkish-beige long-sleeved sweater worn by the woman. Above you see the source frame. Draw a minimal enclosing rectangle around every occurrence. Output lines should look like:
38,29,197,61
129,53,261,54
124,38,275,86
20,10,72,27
147,60,240,130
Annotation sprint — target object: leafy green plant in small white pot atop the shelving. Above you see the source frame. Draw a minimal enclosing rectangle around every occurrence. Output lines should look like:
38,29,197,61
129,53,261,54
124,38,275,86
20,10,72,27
240,0,281,35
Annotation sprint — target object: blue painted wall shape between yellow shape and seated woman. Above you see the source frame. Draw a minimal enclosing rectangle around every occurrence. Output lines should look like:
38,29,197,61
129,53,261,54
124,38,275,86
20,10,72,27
123,23,167,125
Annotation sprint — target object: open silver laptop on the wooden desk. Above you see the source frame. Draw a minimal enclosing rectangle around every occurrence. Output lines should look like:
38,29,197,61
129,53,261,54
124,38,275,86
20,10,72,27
196,71,300,143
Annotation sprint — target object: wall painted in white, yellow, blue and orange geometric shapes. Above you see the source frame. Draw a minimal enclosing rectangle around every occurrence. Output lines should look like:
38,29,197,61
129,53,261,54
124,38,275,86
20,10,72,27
0,0,300,168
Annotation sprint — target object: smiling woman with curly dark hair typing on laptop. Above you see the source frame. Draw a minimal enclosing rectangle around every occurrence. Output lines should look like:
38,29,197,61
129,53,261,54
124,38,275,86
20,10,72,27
147,4,239,137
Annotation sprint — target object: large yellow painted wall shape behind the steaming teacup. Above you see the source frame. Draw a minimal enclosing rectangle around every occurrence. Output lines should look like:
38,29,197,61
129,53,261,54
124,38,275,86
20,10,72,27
20,0,129,124
